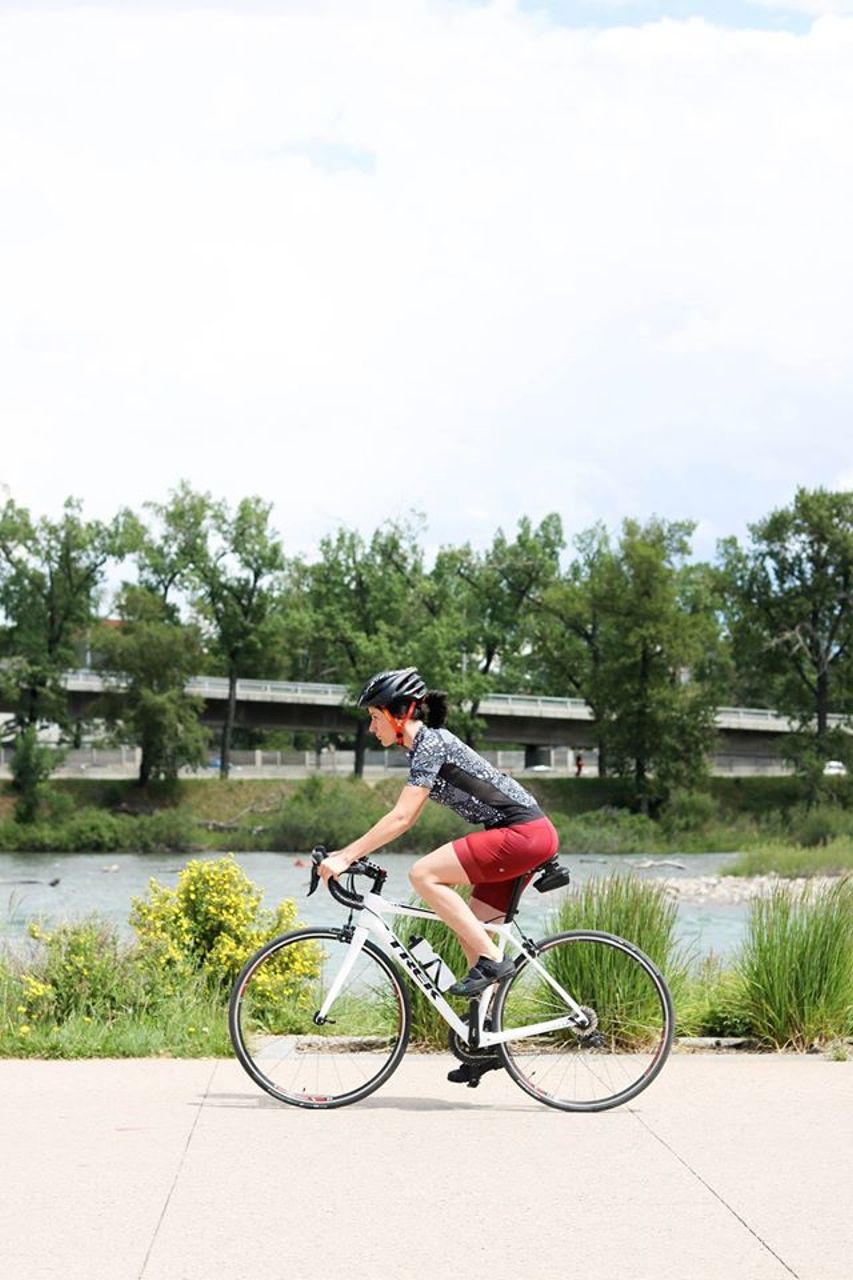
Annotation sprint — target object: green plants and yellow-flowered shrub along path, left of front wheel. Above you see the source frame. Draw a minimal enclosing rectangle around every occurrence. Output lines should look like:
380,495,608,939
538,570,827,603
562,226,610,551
0,858,306,1057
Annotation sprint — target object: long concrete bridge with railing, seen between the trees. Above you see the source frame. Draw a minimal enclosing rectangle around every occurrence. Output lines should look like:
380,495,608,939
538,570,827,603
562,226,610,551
48,671,844,764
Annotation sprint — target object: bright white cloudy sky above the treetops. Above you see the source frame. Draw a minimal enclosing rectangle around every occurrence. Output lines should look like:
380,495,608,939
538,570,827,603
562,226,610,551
0,0,853,554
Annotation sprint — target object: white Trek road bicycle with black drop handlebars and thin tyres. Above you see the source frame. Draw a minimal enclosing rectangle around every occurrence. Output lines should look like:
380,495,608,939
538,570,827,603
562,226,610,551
228,850,674,1111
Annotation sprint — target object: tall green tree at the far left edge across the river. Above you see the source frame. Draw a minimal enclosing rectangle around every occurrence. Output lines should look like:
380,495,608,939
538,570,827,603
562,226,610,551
0,498,129,728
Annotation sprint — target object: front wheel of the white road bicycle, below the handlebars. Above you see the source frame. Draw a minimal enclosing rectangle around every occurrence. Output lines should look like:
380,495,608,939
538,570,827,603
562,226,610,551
231,931,409,1107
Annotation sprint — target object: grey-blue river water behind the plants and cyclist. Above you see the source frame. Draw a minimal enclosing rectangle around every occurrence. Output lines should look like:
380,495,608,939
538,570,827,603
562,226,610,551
0,852,748,957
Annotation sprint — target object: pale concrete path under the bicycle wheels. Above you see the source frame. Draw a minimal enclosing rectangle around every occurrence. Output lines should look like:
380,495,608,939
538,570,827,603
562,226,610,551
0,1055,853,1280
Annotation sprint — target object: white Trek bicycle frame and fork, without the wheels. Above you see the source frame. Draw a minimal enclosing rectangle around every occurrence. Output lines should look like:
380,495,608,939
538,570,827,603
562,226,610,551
316,893,588,1048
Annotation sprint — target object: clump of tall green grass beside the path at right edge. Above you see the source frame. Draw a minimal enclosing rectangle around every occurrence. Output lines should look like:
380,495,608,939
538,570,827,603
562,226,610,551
736,877,853,1050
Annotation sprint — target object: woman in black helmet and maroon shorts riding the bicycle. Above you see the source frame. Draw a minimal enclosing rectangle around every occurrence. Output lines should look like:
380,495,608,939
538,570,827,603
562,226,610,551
320,667,557,1080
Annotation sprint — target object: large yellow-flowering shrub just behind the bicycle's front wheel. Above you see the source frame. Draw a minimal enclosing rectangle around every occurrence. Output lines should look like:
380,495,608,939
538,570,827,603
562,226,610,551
131,854,311,986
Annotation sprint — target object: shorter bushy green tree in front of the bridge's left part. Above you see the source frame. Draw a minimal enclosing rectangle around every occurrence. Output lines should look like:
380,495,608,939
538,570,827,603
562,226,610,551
93,586,207,786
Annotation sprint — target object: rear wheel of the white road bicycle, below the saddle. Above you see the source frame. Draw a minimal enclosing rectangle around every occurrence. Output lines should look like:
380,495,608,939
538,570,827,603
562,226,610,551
493,929,675,1111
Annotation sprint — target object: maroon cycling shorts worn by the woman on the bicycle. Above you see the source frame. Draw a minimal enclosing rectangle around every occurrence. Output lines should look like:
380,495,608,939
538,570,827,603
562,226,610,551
453,818,560,914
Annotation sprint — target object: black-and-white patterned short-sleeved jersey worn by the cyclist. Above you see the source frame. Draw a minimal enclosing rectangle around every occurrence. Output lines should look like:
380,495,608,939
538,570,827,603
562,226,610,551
407,724,543,827
